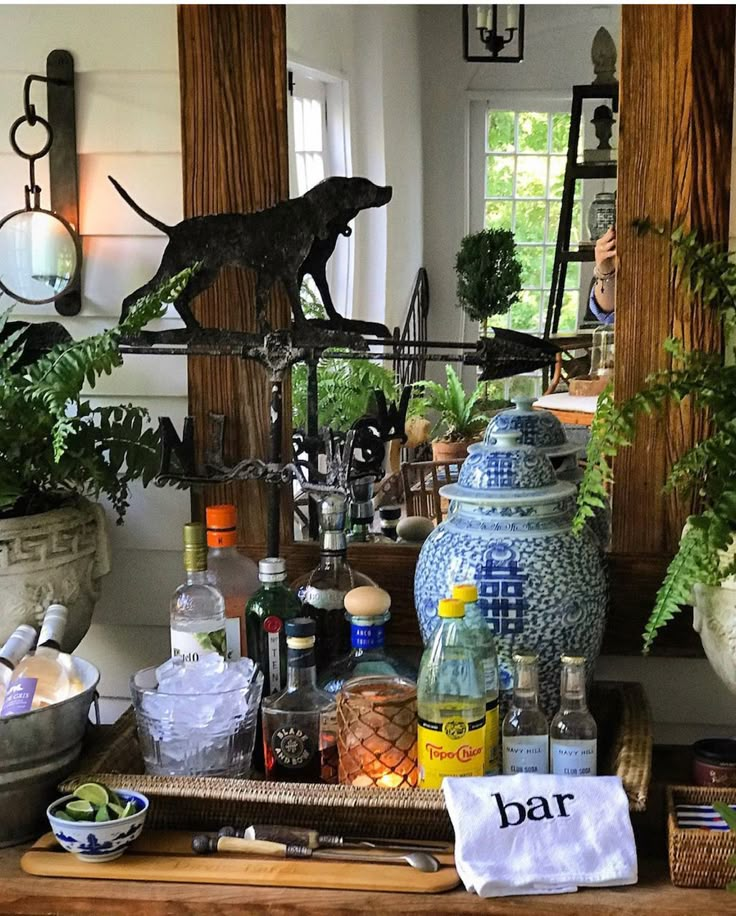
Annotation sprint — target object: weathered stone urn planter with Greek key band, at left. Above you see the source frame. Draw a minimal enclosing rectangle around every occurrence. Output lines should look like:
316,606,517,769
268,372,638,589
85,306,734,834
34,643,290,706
0,499,110,652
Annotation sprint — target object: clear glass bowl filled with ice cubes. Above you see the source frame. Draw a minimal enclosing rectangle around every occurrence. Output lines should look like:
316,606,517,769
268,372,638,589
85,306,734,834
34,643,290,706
130,653,263,778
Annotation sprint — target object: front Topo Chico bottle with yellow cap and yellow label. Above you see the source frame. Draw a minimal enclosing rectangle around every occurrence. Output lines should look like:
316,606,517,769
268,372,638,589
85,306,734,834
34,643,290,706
417,598,486,789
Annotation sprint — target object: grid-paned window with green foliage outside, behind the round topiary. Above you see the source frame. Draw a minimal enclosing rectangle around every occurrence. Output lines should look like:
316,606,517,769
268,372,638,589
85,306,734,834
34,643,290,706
484,108,582,338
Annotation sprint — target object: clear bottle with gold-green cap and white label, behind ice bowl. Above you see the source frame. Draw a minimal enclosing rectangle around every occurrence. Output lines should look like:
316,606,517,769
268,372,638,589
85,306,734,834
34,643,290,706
170,523,227,662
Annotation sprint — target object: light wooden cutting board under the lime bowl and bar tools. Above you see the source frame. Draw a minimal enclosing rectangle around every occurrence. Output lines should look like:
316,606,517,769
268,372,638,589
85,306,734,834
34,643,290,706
20,830,460,894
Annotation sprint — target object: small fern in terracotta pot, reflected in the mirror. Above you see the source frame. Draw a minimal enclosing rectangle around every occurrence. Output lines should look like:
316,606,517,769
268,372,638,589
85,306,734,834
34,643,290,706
417,366,488,461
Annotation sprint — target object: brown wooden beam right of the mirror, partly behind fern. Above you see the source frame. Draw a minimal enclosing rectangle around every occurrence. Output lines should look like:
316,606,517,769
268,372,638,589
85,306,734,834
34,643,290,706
613,5,736,556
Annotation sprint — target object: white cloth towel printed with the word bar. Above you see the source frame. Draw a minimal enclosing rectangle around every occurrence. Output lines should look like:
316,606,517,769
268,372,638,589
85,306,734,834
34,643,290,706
442,773,637,897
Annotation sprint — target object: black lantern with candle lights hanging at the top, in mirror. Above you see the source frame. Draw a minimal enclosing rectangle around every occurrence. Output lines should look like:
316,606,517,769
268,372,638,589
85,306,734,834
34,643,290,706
463,3,524,64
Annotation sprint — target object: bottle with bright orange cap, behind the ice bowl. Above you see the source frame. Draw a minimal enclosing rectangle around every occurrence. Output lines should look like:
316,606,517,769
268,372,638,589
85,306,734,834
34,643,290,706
206,503,260,659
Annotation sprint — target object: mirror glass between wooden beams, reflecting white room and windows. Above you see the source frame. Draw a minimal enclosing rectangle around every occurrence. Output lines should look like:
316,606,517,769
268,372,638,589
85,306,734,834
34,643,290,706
287,5,620,542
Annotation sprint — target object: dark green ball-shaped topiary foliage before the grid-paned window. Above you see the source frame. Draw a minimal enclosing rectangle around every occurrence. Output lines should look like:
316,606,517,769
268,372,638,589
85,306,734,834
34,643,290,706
455,229,522,330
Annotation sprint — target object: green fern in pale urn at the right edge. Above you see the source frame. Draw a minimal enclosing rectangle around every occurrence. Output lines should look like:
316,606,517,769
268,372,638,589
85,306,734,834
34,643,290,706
575,221,736,692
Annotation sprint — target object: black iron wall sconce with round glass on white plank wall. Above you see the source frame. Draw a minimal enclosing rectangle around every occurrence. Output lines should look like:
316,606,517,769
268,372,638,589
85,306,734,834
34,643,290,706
0,50,82,315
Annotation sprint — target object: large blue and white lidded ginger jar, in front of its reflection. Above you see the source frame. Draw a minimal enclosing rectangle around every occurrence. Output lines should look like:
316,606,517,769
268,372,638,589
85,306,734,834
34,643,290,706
414,430,608,715
